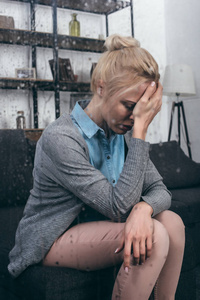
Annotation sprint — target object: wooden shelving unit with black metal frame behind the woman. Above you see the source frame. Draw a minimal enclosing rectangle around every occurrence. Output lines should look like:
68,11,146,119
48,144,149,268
0,0,134,128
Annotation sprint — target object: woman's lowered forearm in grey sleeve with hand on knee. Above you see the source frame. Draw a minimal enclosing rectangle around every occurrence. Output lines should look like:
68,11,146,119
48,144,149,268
116,160,171,272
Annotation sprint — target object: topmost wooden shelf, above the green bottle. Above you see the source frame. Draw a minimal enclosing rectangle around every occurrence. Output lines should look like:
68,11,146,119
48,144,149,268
9,0,131,15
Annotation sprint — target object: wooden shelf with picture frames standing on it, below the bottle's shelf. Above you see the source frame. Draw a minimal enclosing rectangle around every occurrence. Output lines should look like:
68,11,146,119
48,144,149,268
0,78,90,92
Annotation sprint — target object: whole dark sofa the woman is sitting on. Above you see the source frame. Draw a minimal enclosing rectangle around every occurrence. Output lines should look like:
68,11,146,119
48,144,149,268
0,130,200,300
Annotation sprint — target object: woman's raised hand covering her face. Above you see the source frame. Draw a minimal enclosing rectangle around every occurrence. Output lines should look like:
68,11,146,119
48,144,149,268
132,82,163,140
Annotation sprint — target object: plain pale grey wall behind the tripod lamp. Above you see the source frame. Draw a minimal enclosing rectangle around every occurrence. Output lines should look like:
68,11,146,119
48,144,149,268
165,0,200,162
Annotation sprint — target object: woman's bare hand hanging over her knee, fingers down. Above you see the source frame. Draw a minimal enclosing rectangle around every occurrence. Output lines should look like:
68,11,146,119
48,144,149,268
116,202,153,272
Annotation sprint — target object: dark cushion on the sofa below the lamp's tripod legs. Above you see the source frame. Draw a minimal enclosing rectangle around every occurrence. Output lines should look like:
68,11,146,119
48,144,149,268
150,141,200,189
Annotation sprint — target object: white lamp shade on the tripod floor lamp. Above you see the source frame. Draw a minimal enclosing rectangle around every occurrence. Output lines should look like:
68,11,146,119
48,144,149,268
163,64,196,97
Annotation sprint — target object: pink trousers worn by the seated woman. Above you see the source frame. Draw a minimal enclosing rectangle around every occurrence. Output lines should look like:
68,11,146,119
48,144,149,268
43,211,185,300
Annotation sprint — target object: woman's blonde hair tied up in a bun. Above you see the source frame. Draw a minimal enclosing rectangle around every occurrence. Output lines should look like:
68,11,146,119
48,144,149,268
91,34,160,96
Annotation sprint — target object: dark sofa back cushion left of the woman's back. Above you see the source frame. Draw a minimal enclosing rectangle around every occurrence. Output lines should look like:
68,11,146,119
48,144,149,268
0,129,35,207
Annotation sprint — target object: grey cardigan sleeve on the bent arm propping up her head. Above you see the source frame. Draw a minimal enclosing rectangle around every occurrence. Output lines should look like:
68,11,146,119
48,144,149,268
38,118,168,221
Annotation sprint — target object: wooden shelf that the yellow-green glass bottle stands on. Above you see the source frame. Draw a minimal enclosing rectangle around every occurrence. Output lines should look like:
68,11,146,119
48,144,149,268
0,28,104,53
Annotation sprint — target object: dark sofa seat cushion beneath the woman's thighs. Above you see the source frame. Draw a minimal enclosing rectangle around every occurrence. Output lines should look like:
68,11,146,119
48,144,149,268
14,265,116,300
